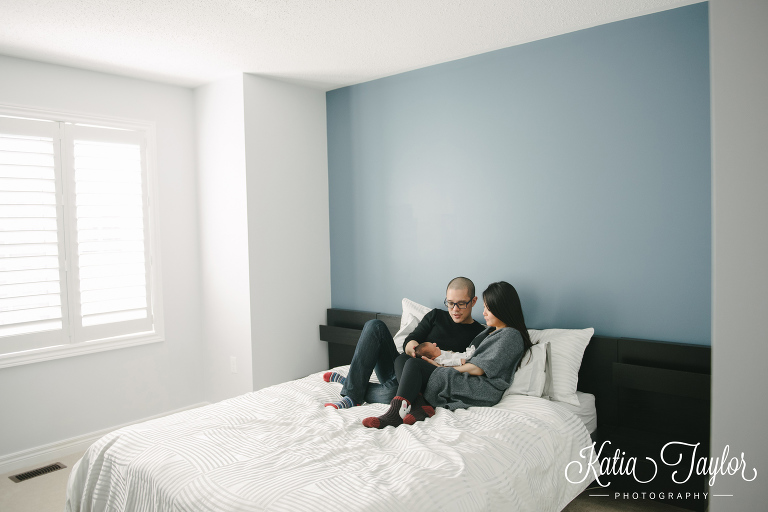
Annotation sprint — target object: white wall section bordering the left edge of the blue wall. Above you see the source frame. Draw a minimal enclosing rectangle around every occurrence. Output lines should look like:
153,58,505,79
244,74,331,389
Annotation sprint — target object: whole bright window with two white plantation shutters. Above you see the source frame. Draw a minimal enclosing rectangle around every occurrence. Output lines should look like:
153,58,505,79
0,109,162,367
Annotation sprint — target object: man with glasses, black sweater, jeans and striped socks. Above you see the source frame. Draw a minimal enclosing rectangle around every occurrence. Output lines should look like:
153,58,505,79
323,277,483,409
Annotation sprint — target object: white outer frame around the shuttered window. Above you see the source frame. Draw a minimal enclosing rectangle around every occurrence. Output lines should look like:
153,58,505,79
0,104,165,368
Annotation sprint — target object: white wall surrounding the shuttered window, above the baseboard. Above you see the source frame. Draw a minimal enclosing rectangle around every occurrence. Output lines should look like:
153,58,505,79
0,56,203,456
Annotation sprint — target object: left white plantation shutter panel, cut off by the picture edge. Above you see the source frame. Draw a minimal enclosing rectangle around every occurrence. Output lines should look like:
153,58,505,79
0,117,67,352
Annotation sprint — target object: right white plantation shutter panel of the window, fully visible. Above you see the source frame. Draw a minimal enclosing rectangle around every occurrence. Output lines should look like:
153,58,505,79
66,125,152,341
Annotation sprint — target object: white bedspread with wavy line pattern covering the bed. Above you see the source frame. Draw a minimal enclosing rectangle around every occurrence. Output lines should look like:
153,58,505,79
67,367,592,512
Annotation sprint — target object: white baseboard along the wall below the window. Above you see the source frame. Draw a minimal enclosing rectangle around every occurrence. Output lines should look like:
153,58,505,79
0,402,209,475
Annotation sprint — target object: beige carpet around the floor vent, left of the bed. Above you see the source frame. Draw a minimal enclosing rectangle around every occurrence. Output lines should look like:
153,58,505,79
0,452,83,512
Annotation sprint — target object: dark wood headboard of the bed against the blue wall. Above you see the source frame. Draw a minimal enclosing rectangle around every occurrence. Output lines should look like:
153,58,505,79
320,309,711,510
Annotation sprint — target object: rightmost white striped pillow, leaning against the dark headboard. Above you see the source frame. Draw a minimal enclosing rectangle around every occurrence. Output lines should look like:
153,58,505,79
528,327,595,406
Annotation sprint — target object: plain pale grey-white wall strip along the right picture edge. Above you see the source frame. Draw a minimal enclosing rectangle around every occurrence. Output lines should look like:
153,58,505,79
709,0,768,512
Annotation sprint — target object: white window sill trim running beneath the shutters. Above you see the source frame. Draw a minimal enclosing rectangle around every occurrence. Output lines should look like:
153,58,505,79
0,332,164,368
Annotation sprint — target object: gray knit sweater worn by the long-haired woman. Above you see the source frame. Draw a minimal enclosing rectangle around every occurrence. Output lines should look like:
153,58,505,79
424,327,524,411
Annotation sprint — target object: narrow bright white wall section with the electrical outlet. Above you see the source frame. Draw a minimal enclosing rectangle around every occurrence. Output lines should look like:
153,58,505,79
195,74,253,402
